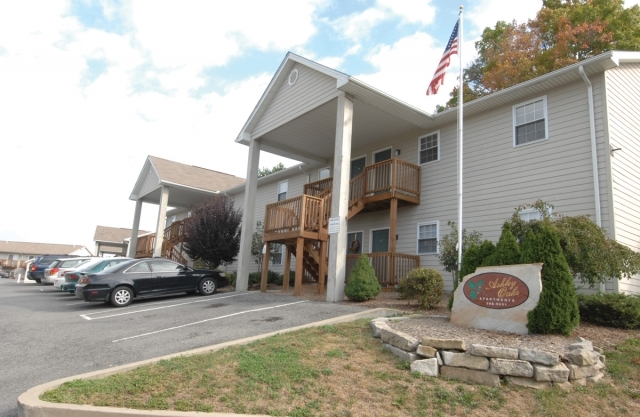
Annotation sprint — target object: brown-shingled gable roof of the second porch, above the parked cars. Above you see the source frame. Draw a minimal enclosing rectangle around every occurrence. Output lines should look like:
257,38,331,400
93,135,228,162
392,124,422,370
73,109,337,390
129,155,245,200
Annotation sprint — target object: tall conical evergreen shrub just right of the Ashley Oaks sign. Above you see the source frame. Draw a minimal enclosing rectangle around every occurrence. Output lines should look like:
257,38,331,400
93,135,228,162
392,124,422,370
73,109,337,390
521,220,580,336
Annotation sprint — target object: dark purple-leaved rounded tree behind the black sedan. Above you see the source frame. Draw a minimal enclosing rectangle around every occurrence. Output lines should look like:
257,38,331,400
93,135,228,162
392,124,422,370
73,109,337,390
184,195,242,268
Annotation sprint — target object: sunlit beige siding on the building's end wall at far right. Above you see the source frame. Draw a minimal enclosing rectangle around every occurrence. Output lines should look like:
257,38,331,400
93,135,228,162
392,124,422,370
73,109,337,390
605,64,640,293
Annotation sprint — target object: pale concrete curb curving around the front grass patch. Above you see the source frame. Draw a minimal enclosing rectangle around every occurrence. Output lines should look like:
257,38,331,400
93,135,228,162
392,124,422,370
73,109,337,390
18,308,402,417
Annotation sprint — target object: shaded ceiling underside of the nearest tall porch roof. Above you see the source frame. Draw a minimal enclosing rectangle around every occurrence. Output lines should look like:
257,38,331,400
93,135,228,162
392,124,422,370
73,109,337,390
260,99,420,162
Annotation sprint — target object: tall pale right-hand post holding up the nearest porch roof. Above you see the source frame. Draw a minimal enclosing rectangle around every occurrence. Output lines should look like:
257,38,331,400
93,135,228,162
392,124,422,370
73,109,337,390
327,93,353,302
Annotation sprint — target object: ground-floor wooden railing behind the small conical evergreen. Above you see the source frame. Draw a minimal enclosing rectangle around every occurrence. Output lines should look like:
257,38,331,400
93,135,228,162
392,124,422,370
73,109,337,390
346,252,420,287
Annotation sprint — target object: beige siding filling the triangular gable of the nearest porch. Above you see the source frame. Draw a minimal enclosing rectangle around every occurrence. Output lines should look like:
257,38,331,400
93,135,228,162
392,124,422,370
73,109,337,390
251,64,336,137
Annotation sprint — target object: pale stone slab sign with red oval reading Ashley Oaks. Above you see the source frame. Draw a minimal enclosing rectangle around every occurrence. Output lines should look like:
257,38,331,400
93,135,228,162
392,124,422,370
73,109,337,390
451,264,542,334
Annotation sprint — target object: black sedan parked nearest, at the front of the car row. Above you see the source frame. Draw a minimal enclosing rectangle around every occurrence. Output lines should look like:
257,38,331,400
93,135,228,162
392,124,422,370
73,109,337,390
75,258,229,307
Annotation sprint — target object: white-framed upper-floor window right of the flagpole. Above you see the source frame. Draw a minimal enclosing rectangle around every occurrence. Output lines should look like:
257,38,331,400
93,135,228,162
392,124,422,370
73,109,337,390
513,96,548,146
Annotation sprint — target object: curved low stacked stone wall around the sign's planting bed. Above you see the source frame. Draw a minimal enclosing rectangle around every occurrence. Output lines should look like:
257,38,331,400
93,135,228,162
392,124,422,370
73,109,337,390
371,317,606,389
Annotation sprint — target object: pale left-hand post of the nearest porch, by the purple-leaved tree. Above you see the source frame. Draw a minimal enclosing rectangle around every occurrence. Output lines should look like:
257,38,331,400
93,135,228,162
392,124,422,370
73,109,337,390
236,138,260,292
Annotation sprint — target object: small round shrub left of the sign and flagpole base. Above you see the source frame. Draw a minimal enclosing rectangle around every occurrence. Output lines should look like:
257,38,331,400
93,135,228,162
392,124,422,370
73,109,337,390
398,268,444,309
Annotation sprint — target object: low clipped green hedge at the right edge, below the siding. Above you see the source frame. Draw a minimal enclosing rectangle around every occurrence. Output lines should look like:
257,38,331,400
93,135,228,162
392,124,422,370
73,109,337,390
578,293,640,329
